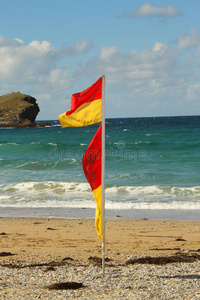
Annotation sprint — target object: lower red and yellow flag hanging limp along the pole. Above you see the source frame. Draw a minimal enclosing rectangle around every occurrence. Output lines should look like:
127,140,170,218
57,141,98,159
82,125,103,241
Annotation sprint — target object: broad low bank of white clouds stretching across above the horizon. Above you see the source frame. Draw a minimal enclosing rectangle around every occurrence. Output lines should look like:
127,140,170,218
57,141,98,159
0,28,200,118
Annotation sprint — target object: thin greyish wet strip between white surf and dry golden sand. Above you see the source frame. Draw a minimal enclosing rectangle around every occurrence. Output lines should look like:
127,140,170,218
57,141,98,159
0,207,200,221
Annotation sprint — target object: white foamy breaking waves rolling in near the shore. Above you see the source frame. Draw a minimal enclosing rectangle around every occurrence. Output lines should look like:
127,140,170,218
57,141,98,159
0,181,200,209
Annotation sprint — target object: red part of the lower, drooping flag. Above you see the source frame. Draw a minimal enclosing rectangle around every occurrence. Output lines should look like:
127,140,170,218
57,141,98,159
82,125,102,190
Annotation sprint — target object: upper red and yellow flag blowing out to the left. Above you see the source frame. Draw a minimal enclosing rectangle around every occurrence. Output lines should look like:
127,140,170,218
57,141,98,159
58,77,102,128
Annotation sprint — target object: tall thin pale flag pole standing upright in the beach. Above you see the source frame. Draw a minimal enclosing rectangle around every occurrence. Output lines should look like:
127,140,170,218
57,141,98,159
101,75,105,276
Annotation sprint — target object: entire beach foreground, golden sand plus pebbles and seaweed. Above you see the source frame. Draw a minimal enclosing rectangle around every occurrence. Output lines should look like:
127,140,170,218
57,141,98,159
0,218,200,299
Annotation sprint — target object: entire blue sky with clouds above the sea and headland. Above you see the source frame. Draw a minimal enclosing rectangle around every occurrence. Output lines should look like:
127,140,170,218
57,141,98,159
0,0,200,120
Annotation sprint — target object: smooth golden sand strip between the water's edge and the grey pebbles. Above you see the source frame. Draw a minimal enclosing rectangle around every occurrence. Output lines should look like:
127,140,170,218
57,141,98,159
0,218,200,263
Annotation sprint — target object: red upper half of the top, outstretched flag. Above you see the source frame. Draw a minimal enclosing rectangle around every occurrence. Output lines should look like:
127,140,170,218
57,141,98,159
66,77,102,116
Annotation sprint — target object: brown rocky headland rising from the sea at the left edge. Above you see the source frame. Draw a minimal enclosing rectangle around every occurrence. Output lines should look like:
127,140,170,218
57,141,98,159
0,92,40,127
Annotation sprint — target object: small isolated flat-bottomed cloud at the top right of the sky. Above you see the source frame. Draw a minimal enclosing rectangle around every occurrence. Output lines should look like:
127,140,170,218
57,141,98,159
131,2,183,18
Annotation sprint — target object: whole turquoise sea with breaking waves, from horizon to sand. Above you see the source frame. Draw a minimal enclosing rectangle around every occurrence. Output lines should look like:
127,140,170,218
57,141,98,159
0,116,200,220
